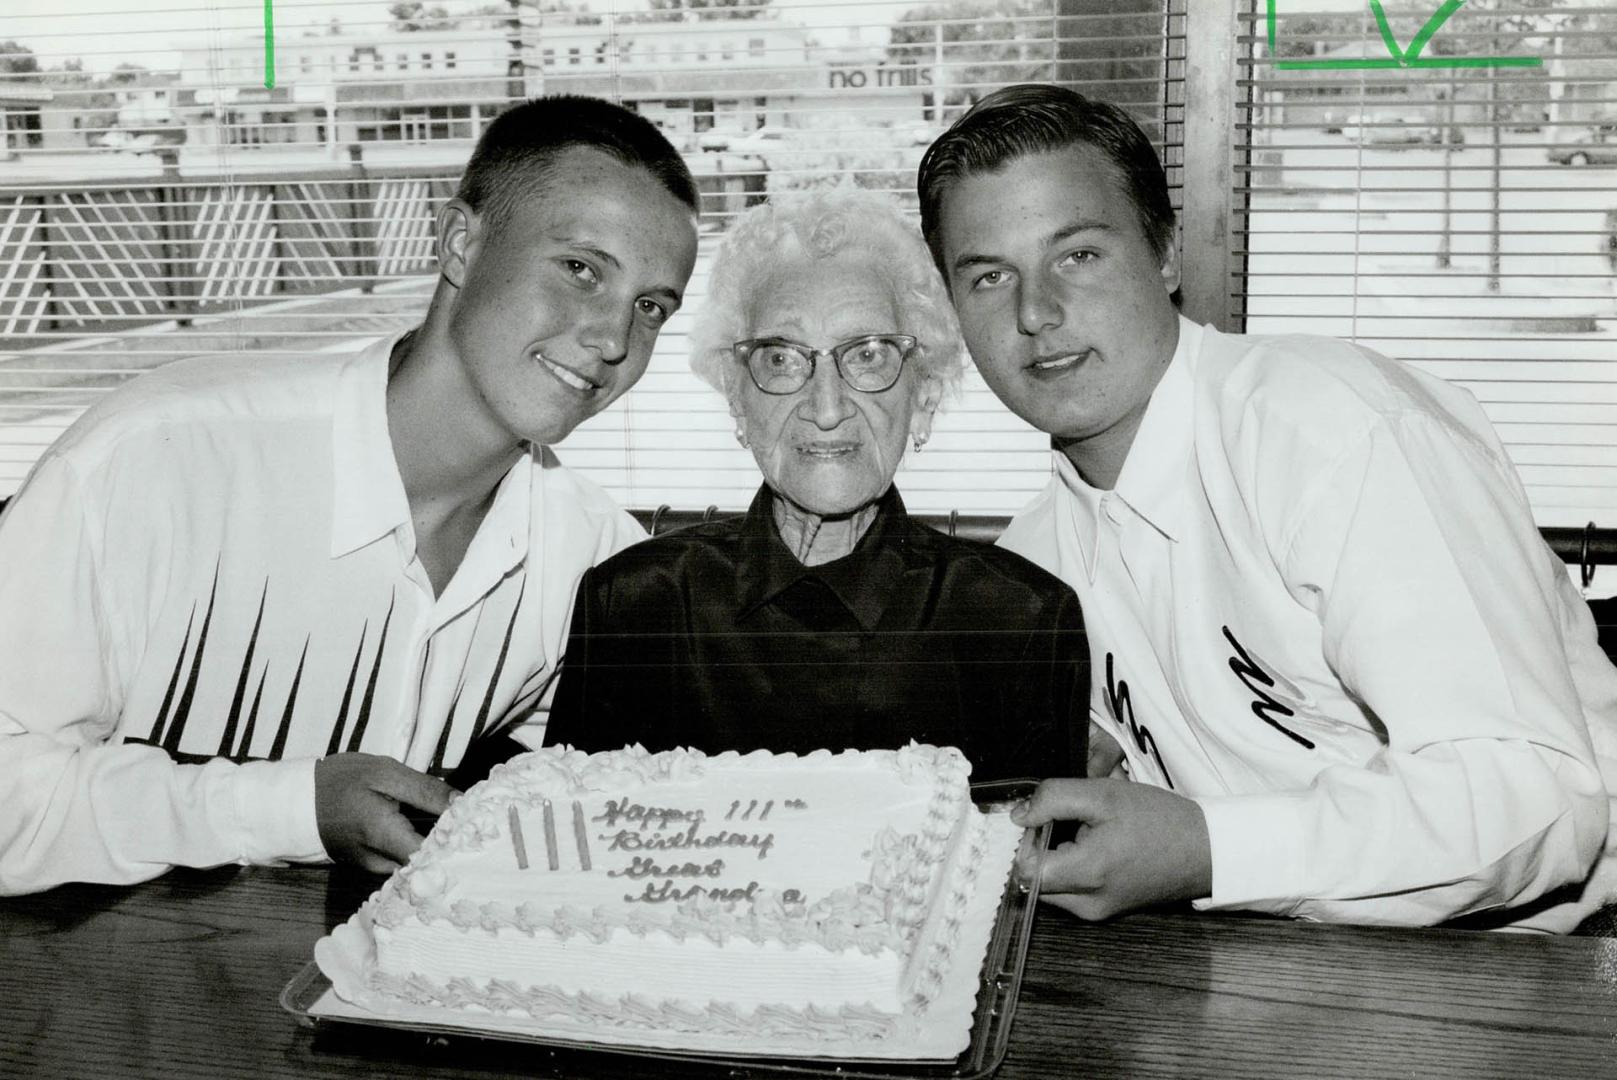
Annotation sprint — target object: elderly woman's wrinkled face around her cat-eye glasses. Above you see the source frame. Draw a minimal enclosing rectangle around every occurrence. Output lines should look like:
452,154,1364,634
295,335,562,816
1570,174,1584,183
734,259,923,516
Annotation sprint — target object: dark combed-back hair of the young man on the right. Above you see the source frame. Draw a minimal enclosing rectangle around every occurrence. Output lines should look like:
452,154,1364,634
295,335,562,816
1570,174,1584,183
915,82,1174,276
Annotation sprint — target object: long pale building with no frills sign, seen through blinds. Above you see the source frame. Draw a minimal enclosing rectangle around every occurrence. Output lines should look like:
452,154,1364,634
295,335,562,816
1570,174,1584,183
168,15,933,157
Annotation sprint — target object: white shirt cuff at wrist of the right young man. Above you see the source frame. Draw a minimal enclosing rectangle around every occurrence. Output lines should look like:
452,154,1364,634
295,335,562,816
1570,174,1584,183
1192,795,1308,913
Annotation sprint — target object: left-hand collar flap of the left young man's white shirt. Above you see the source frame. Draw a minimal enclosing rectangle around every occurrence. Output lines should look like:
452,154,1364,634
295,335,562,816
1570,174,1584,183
331,331,409,558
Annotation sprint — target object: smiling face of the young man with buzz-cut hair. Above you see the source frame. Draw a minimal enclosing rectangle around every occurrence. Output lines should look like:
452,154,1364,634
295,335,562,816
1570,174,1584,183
440,147,697,443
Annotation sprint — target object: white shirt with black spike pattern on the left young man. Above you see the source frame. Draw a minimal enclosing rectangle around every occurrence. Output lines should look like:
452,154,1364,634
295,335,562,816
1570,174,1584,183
0,338,644,892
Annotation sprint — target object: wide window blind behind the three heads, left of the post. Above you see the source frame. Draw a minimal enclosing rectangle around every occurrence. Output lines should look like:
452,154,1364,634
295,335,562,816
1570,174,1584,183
0,0,1184,514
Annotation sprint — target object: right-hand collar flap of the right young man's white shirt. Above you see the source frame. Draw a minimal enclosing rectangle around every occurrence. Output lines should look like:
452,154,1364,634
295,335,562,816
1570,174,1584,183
1116,315,1201,540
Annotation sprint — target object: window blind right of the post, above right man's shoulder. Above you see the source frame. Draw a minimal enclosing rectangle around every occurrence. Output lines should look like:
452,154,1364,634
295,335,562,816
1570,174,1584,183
1227,0,1617,527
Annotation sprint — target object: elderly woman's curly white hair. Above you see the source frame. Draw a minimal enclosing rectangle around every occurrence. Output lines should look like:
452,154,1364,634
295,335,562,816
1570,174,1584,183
690,188,965,402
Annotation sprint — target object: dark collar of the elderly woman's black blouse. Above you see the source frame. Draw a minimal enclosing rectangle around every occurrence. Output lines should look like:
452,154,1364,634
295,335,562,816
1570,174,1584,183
739,485,909,631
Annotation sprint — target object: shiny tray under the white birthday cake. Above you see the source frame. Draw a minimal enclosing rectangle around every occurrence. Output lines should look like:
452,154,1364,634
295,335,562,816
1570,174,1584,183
281,781,1049,1080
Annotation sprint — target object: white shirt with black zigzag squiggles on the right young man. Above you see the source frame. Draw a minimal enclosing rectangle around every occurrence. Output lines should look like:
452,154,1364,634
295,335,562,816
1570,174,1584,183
1001,313,1617,931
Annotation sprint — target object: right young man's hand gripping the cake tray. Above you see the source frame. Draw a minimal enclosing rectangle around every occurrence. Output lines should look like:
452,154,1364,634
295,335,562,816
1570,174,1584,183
1011,779,1213,918
